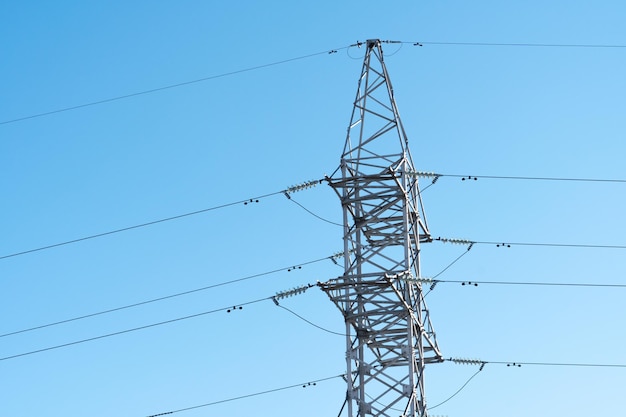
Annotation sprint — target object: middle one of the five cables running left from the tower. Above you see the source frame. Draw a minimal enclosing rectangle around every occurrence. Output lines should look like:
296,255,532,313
0,256,330,338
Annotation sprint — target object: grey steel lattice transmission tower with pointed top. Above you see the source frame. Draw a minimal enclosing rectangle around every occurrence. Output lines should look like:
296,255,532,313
319,39,443,417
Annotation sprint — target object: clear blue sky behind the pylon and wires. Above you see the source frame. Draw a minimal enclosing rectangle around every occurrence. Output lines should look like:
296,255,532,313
0,0,626,417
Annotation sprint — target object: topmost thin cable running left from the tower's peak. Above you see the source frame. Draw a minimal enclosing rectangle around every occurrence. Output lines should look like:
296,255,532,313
0,46,348,125
